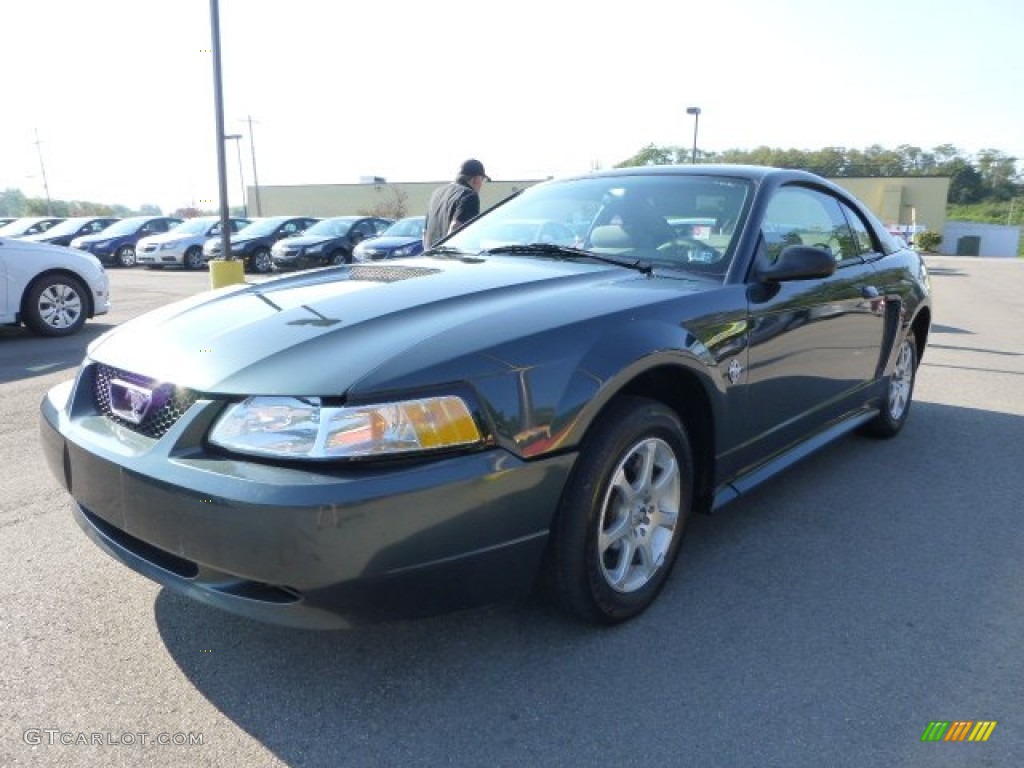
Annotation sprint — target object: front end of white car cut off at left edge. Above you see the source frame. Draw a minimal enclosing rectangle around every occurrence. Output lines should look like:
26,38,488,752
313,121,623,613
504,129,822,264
0,238,111,336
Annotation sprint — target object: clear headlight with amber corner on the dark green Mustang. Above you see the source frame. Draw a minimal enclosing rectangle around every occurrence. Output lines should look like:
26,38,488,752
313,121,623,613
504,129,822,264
210,395,482,459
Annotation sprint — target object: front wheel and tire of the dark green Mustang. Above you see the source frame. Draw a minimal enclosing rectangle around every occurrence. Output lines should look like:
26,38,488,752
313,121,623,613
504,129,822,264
543,397,693,624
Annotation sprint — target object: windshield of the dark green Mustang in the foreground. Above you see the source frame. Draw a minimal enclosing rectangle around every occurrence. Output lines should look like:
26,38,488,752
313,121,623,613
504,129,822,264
444,171,753,279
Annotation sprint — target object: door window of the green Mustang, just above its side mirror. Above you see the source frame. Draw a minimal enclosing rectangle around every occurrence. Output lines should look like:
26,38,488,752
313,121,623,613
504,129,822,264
761,186,860,262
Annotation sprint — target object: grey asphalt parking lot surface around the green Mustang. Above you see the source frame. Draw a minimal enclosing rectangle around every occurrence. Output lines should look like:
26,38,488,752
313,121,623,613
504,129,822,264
0,256,1024,768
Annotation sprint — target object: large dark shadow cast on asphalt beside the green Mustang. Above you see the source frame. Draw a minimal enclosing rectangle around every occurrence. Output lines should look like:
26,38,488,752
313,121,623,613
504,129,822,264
155,402,1024,766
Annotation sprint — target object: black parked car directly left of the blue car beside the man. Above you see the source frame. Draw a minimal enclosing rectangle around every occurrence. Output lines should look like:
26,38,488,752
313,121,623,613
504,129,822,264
270,216,394,271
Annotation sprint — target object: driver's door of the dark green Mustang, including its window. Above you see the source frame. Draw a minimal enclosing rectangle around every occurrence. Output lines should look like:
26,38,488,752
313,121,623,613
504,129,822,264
745,184,885,456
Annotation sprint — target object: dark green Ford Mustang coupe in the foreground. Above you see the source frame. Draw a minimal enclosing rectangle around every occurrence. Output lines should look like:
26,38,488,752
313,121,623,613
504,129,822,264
41,165,932,627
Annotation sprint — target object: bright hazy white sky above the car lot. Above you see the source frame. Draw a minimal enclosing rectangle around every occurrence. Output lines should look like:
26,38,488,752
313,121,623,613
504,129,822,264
0,0,1024,212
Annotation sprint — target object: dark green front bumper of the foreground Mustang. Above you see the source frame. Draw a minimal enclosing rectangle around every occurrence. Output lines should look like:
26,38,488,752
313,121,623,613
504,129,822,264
40,372,573,629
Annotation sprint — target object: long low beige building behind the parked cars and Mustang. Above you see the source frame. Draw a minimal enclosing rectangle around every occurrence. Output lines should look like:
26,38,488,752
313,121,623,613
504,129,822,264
247,176,949,233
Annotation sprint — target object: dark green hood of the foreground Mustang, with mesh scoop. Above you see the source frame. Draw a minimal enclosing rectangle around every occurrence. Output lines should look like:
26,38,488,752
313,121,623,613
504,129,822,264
89,257,704,396
